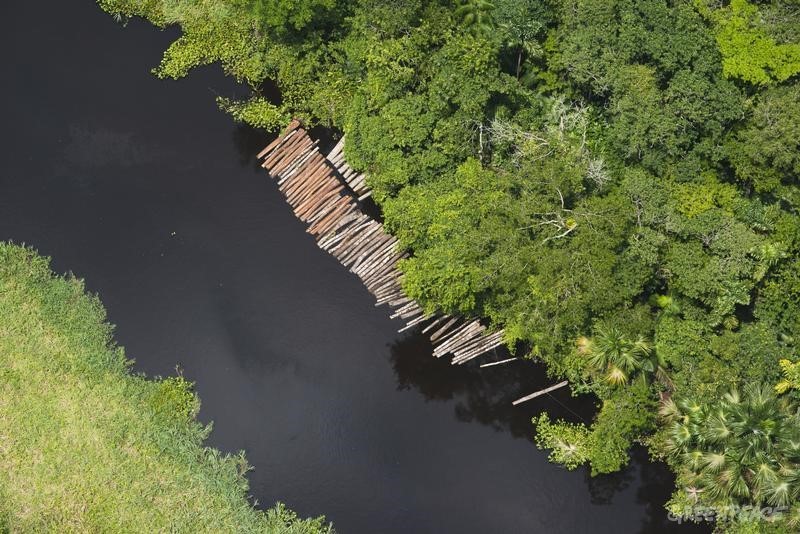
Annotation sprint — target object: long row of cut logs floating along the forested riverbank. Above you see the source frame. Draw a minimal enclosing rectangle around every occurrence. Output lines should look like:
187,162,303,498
258,120,503,364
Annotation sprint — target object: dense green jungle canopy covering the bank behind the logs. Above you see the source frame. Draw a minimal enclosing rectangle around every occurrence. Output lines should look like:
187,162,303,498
98,0,800,531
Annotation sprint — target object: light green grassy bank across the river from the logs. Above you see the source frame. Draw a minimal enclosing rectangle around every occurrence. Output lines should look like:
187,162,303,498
0,243,330,534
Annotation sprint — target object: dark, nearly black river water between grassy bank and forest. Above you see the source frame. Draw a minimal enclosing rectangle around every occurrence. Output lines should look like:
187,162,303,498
0,0,708,533
